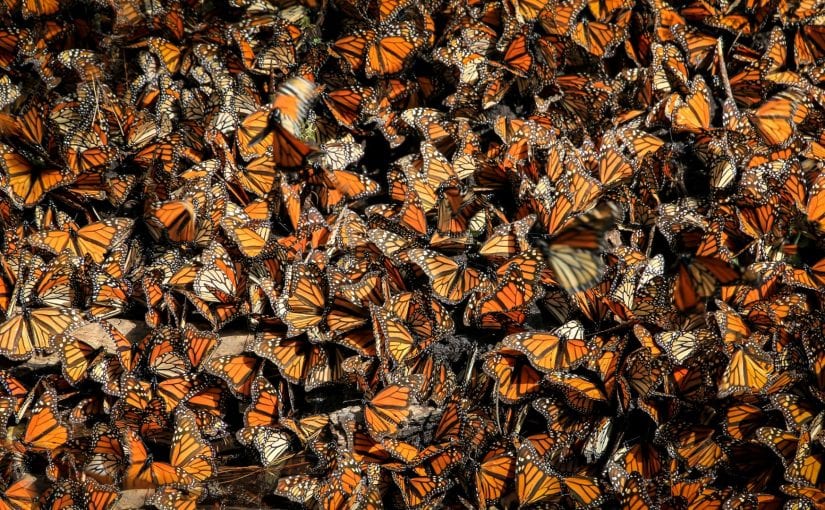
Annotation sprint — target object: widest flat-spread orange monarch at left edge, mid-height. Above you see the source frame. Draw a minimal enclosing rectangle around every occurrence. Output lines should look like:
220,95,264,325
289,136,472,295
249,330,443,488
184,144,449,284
29,218,134,264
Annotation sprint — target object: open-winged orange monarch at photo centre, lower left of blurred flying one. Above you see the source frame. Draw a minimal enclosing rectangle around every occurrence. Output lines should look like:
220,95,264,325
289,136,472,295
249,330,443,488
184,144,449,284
407,248,479,304
